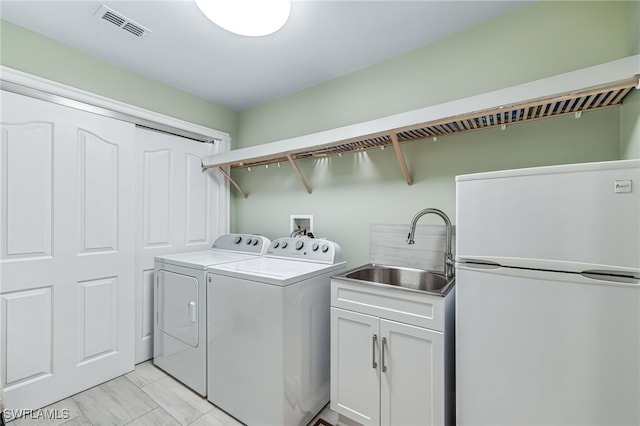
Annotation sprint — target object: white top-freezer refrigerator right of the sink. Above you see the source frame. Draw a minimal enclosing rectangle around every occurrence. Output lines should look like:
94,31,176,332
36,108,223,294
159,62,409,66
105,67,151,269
456,160,640,426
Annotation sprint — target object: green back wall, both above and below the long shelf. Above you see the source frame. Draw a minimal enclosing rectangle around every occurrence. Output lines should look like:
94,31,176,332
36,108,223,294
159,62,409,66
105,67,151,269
232,1,640,266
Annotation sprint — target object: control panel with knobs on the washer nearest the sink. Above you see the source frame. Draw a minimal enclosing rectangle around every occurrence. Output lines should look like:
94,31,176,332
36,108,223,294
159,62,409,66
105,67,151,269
266,237,342,264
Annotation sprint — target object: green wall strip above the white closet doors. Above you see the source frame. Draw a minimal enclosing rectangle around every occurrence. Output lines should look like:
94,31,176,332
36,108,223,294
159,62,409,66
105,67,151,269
0,20,237,135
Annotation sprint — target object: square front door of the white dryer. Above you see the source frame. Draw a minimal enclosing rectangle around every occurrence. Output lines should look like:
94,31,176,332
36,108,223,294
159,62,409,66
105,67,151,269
157,270,199,348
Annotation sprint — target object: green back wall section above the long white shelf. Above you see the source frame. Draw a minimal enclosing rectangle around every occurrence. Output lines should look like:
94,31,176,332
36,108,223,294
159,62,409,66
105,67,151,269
236,1,640,147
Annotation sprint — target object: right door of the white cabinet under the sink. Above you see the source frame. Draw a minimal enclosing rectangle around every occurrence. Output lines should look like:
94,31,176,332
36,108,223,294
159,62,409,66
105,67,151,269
380,320,445,426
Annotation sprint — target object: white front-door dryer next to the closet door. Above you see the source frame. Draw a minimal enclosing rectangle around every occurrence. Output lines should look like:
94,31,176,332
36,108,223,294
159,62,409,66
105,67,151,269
153,234,270,396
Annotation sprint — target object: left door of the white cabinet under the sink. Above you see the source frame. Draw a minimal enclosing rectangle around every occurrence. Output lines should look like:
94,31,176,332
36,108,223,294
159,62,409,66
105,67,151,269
331,308,380,426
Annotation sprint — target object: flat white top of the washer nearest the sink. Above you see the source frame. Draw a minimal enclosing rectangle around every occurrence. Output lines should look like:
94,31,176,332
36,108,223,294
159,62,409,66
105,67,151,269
207,257,345,286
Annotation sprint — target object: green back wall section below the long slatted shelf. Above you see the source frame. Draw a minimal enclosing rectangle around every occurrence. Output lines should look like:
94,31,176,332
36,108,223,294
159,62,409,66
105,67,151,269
232,109,620,266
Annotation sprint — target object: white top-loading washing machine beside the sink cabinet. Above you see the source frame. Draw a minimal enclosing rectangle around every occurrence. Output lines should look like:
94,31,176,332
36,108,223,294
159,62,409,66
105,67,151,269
207,238,346,426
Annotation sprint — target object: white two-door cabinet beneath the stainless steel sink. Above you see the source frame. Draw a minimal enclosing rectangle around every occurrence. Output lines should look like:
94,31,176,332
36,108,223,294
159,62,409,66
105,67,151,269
331,278,454,426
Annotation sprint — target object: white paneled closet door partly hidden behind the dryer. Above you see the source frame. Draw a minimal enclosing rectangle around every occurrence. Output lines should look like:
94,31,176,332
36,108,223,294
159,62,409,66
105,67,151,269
135,128,228,363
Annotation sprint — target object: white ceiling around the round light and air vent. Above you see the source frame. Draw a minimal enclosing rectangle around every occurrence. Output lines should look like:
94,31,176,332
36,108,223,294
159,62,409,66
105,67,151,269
0,0,528,111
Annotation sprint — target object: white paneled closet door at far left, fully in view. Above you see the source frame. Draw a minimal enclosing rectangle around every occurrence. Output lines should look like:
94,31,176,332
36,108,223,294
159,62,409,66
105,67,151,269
0,91,135,408
